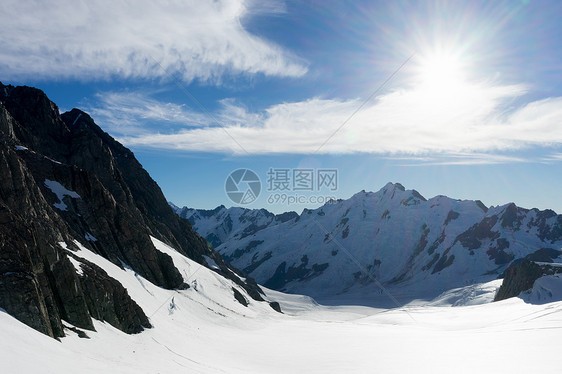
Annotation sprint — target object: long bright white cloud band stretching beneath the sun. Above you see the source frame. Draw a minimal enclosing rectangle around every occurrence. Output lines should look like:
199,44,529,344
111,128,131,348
94,79,562,164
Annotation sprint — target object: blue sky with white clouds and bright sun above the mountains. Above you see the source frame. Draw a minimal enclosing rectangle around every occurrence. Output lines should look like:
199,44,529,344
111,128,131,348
0,0,562,213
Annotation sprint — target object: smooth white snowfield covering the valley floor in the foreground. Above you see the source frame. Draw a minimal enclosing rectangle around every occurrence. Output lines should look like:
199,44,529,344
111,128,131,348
0,238,562,374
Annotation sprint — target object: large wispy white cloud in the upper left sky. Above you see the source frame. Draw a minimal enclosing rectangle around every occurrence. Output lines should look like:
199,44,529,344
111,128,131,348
0,0,306,81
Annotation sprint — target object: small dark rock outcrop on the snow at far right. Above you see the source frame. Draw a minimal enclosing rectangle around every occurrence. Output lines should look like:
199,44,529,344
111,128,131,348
494,259,561,301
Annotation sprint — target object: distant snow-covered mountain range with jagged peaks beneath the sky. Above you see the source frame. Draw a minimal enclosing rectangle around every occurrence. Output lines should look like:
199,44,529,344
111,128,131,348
177,183,562,302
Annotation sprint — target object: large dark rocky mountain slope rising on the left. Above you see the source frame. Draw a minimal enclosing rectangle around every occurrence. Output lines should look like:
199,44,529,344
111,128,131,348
0,83,261,337
